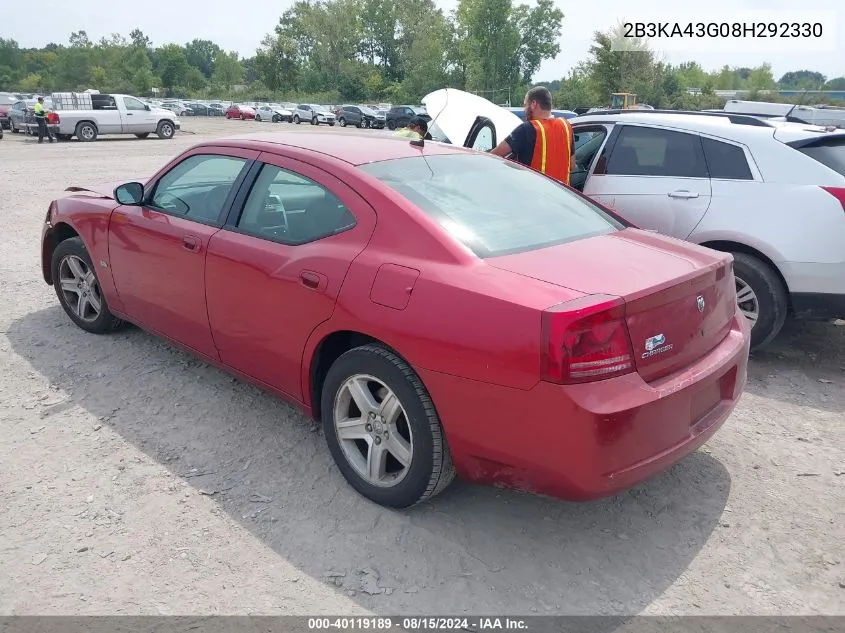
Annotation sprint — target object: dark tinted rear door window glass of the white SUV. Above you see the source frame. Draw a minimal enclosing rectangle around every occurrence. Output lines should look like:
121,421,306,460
606,125,709,178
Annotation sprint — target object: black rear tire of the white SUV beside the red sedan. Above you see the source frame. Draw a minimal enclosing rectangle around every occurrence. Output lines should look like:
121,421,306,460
733,253,789,349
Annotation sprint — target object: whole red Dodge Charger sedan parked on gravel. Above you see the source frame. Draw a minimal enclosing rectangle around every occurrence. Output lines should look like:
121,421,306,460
42,132,749,507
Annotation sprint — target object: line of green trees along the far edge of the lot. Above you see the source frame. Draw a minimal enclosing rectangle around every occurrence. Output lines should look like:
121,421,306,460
0,0,845,109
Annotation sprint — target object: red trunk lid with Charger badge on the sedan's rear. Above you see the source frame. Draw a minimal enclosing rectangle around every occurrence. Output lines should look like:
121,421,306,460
487,229,736,380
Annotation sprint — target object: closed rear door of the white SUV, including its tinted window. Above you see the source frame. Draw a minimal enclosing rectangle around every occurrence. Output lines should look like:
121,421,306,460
584,124,712,239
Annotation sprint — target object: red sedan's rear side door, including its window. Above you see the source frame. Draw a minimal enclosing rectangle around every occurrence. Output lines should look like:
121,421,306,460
206,154,375,400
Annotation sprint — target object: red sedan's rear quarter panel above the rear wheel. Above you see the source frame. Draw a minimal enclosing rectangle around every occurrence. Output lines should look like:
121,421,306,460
302,180,581,393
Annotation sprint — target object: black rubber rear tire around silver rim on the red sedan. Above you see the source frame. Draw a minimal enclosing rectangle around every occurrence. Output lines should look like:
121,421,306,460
320,345,455,508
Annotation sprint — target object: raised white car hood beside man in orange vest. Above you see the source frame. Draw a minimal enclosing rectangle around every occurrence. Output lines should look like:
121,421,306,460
422,88,522,146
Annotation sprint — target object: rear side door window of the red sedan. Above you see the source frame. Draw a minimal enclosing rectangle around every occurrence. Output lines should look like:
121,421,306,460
237,165,355,245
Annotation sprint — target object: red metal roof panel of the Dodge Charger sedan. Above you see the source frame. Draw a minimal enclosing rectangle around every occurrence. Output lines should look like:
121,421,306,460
214,132,472,166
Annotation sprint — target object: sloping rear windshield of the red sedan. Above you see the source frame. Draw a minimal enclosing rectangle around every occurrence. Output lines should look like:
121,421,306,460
361,154,623,258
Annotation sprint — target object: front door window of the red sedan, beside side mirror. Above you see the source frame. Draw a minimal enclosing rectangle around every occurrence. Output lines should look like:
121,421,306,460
148,154,246,223
